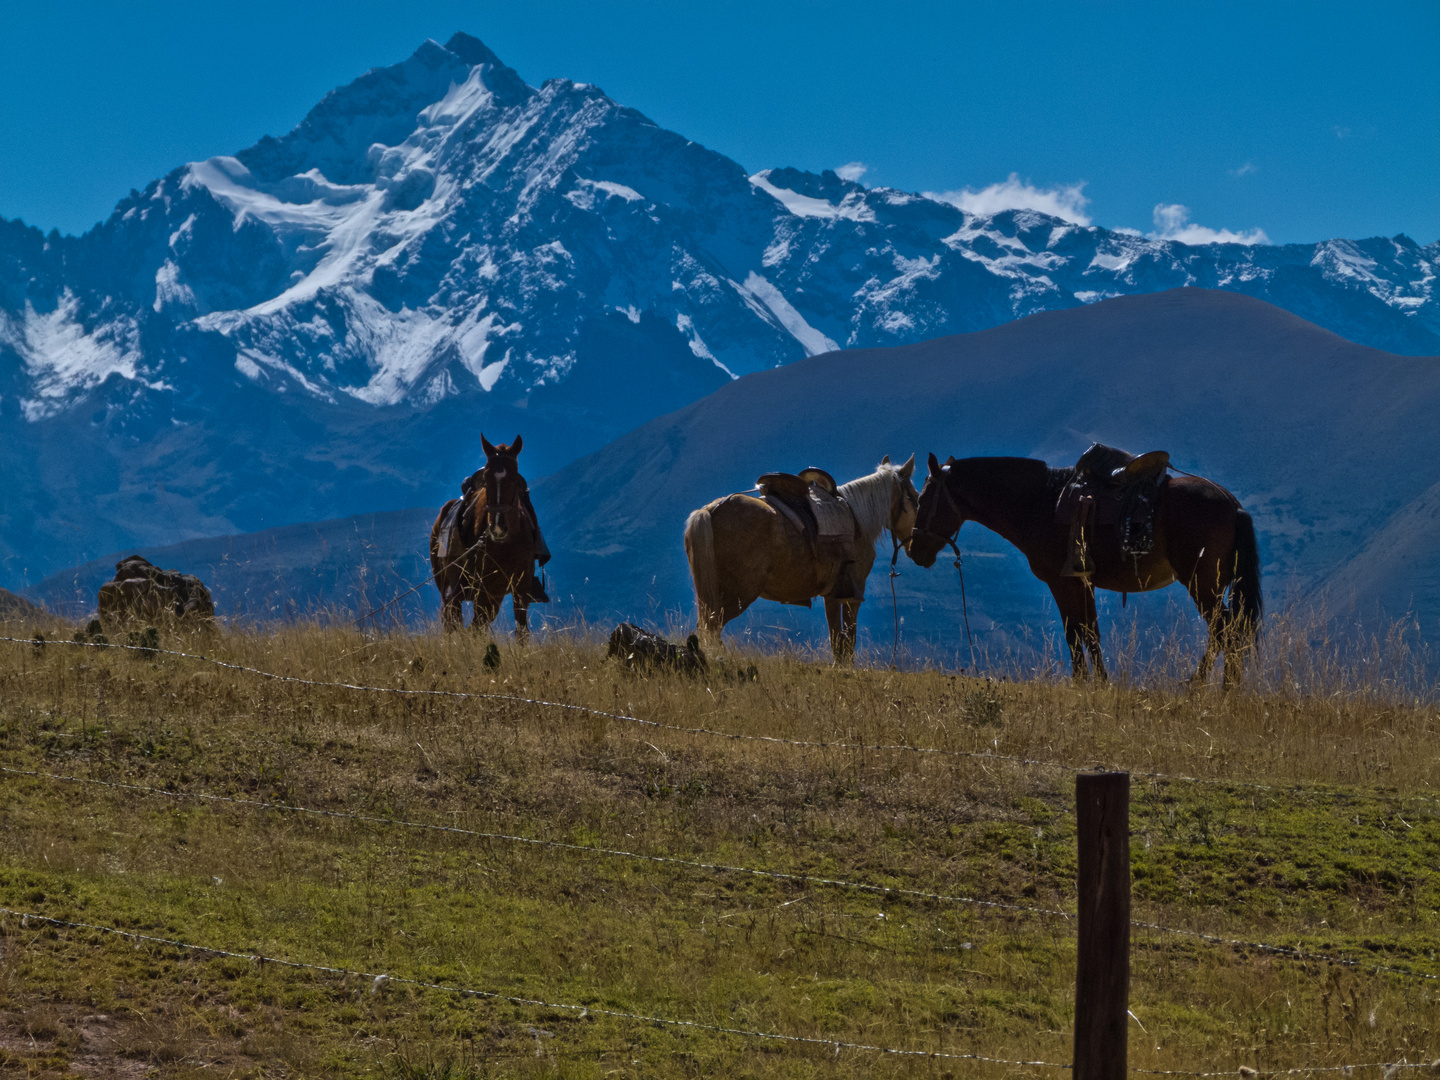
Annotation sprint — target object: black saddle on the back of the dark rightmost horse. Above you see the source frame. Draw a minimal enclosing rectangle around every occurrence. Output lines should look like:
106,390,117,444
1056,442,1169,577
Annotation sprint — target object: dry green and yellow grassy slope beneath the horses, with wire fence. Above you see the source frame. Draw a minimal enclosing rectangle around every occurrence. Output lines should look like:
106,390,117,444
0,628,1440,1077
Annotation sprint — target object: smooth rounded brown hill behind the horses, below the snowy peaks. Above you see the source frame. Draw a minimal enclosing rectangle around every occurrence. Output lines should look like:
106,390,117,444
33,289,1440,664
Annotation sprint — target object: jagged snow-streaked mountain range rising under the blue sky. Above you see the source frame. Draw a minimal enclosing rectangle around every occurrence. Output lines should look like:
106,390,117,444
0,35,1440,580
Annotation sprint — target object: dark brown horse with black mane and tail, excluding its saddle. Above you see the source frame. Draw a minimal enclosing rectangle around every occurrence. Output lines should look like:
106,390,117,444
906,454,1261,688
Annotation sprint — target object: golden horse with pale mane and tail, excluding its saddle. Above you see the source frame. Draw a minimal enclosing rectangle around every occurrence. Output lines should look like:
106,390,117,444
685,454,919,664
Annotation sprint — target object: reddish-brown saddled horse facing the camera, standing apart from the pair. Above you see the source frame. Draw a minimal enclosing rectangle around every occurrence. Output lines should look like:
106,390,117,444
431,435,549,641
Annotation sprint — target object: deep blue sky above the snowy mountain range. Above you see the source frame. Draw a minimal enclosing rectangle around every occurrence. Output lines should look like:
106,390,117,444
0,0,1440,243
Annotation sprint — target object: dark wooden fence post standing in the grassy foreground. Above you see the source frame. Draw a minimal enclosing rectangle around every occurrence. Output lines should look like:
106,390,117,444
1074,772,1130,1080
